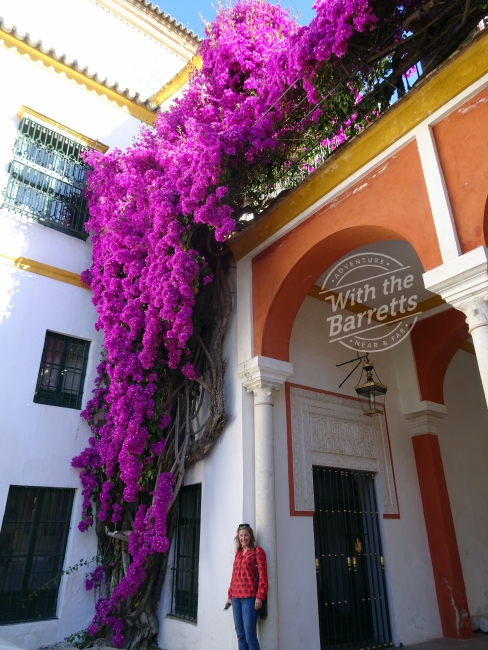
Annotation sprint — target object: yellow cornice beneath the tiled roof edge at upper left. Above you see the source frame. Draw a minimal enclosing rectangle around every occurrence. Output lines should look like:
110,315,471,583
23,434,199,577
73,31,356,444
0,25,156,124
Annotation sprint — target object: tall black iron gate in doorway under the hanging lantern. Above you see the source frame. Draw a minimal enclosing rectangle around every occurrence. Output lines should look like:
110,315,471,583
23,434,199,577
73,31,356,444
313,467,393,650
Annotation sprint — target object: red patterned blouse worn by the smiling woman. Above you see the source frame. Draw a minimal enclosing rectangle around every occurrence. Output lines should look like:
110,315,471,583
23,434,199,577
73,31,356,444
228,546,268,600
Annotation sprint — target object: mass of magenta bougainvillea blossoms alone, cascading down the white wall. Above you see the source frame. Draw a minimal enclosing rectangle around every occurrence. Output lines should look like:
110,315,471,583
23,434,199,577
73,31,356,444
72,0,374,644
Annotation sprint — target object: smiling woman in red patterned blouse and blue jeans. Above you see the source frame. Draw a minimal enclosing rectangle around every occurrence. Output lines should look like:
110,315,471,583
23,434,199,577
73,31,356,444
225,524,268,650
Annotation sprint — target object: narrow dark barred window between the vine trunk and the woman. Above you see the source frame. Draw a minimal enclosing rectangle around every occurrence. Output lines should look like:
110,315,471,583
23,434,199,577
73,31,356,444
171,484,202,621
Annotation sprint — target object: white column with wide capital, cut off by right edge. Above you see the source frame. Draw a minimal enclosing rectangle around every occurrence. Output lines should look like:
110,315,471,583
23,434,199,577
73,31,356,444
424,246,488,403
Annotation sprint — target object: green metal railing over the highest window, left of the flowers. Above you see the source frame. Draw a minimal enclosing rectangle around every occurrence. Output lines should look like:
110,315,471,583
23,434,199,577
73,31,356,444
3,117,88,239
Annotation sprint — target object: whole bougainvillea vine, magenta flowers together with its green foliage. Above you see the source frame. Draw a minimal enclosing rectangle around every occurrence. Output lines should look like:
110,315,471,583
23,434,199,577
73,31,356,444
72,0,488,647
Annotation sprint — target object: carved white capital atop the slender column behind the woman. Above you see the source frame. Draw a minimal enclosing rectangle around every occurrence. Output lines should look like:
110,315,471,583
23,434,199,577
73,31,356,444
238,356,293,405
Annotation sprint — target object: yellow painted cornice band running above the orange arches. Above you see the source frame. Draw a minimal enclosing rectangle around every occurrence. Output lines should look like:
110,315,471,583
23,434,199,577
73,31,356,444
228,33,488,260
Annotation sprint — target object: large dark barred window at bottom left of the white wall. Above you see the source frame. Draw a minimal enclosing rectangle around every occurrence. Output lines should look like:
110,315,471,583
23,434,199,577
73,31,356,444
0,485,74,625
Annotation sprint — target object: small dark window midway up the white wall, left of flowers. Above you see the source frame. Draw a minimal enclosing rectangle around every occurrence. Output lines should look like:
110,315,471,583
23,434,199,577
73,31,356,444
34,332,90,409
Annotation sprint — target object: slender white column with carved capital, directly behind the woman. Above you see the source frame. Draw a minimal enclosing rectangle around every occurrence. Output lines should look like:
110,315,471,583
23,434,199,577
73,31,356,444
239,357,293,650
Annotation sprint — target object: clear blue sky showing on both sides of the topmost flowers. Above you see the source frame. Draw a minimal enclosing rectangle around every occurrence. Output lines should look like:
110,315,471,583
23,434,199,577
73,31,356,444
152,0,315,36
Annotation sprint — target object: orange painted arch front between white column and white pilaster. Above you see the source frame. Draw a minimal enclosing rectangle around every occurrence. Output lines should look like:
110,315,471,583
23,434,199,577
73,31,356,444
252,142,442,361
